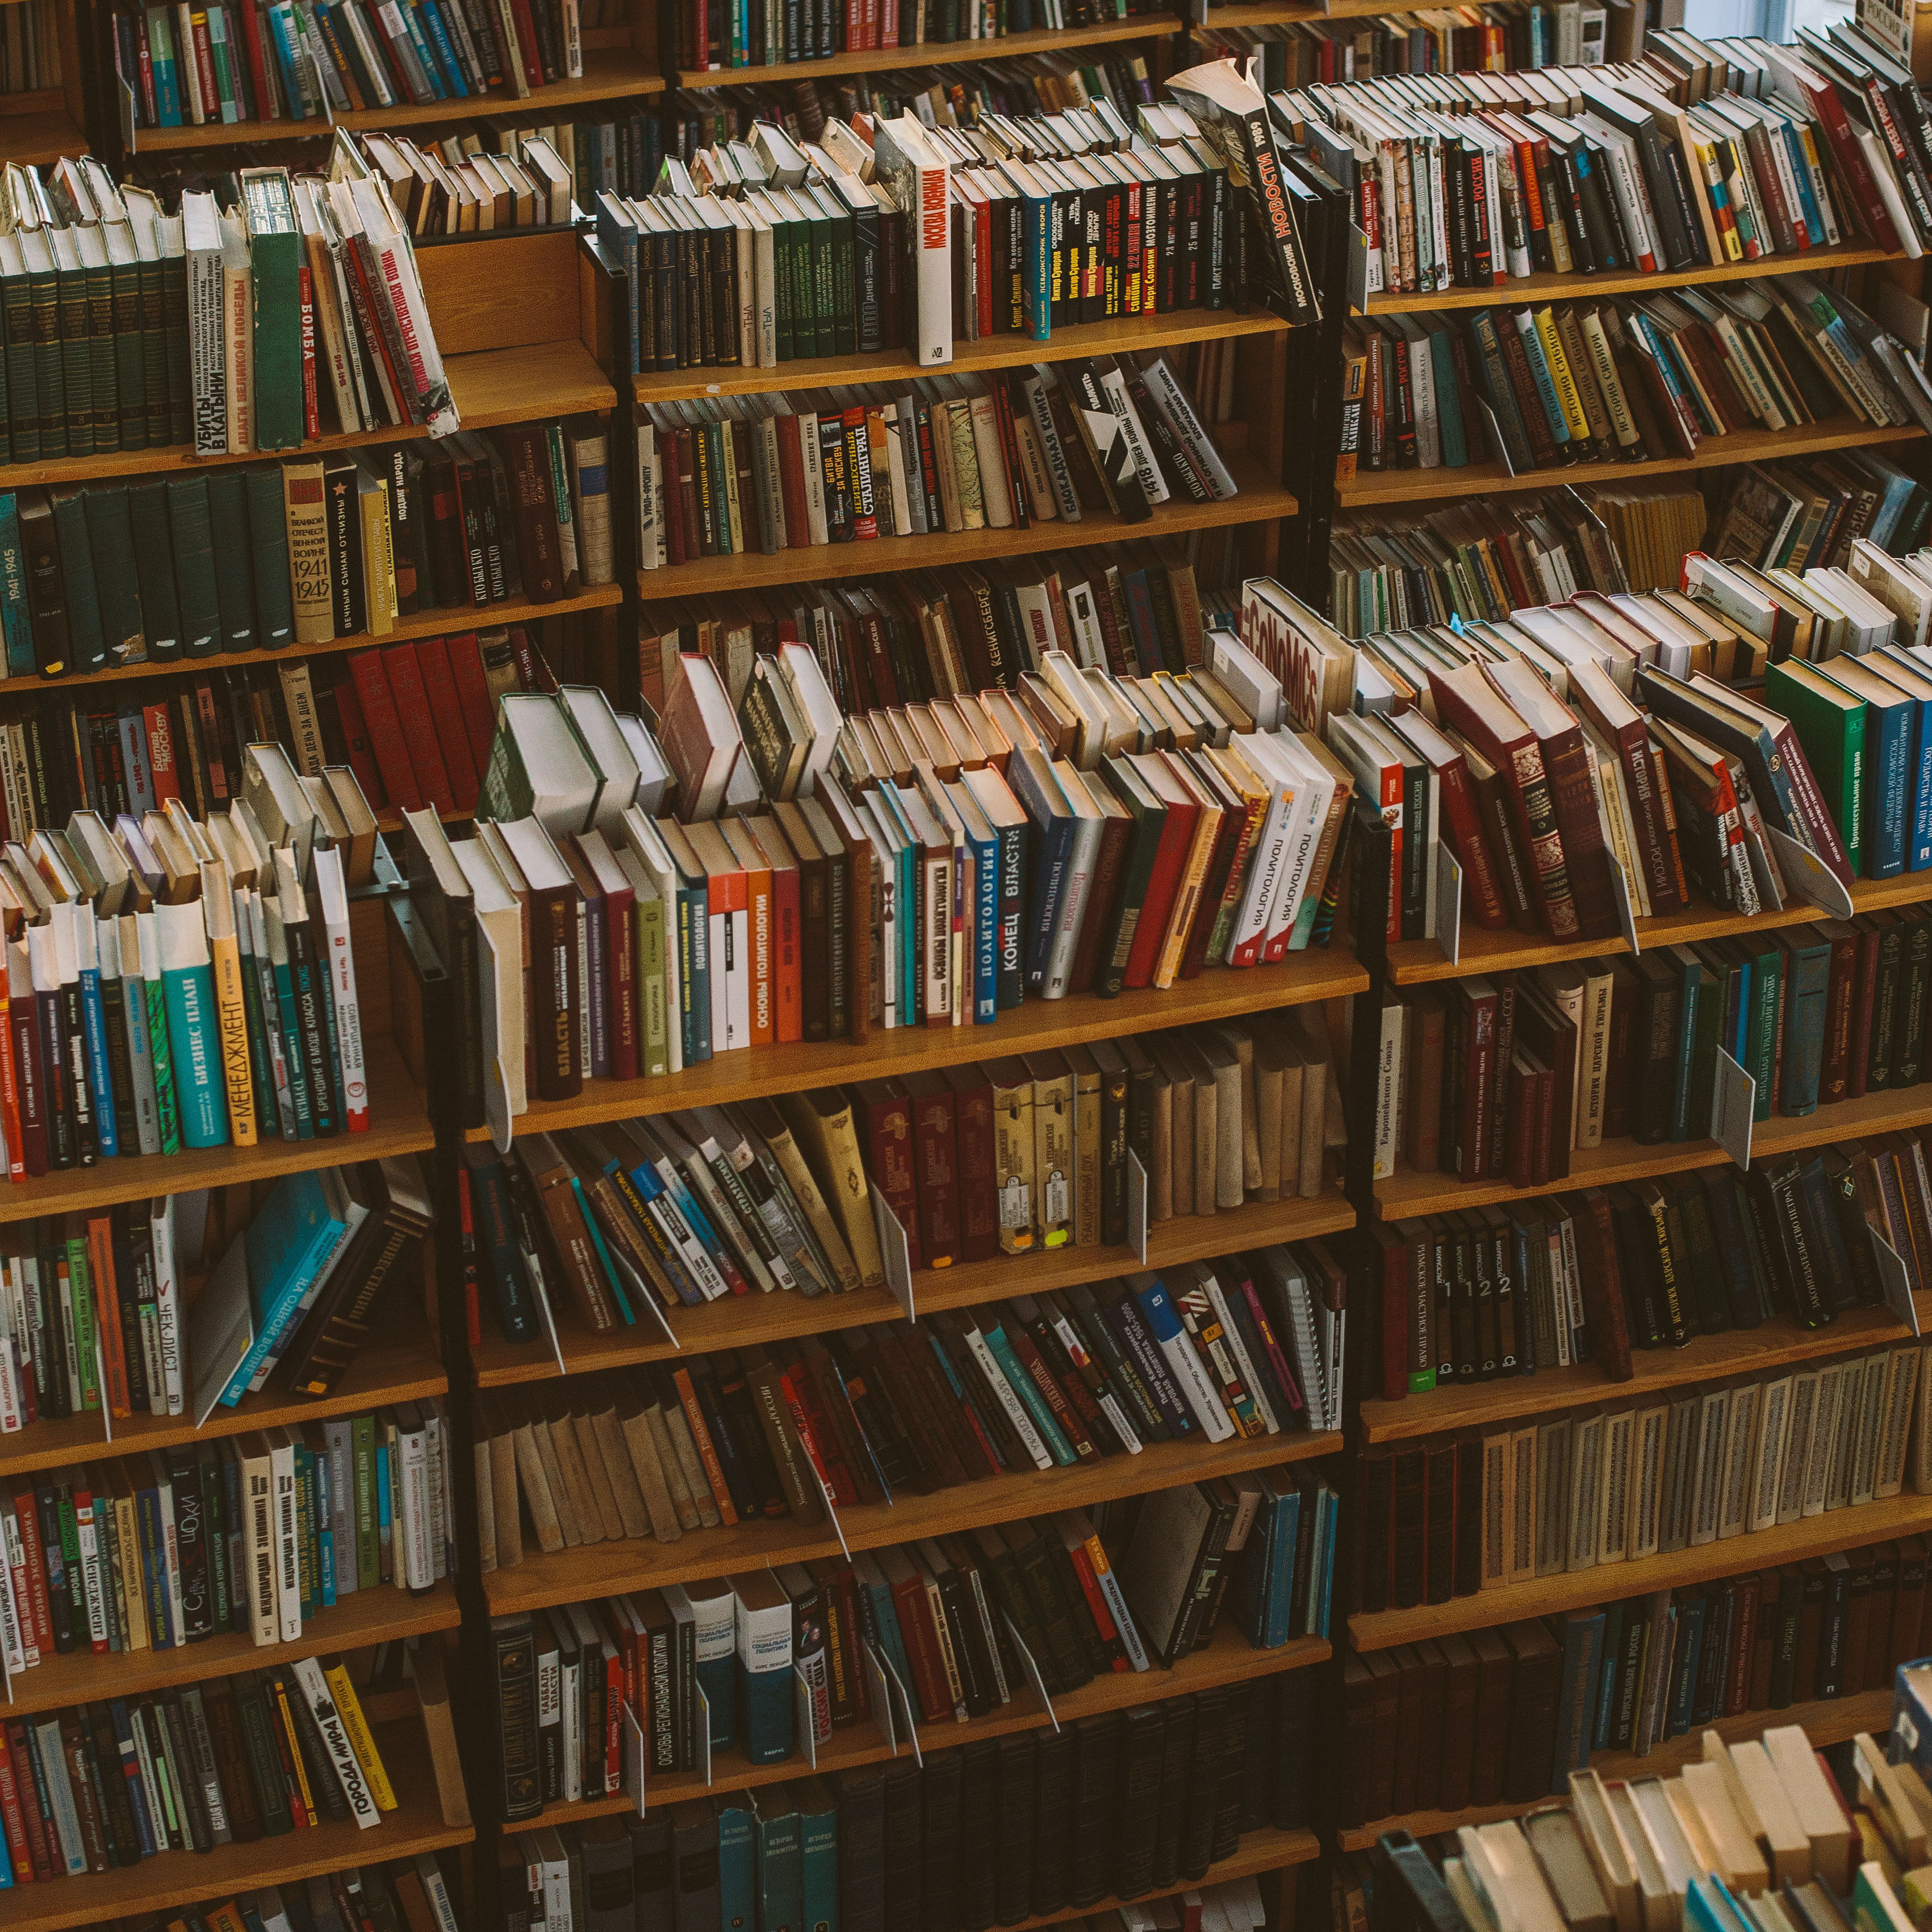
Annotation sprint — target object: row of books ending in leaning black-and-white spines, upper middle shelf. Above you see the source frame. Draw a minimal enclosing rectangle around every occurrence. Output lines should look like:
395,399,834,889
638,352,1239,564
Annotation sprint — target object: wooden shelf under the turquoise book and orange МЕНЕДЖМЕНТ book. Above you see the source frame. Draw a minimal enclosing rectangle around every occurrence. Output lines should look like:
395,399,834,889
0,1035,437,1221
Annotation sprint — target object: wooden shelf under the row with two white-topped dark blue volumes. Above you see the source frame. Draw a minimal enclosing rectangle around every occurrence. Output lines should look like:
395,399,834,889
512,1623,1333,1831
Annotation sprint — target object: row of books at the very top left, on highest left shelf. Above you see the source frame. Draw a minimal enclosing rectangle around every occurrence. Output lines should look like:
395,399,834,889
110,0,583,128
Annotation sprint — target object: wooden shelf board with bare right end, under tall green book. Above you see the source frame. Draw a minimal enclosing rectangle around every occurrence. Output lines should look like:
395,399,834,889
0,342,616,491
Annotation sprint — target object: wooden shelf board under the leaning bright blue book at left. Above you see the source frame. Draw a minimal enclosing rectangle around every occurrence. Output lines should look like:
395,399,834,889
0,1289,450,1494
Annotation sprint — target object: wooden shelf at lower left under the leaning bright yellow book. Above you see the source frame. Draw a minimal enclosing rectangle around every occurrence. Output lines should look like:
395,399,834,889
0,1717,475,1932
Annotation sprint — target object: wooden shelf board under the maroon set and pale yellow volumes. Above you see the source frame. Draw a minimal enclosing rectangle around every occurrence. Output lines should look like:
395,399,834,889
470,1194,1354,1391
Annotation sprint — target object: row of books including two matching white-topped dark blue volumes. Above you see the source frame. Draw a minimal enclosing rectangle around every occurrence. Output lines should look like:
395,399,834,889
493,1470,1333,1822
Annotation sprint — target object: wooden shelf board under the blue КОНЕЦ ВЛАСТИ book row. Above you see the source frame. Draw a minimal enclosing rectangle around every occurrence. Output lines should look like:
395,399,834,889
466,948,1368,1142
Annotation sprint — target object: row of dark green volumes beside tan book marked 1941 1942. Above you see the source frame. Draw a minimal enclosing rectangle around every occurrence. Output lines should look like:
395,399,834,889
0,417,612,678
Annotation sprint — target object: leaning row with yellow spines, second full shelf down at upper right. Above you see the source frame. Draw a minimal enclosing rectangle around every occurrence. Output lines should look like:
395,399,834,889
1350,274,1932,475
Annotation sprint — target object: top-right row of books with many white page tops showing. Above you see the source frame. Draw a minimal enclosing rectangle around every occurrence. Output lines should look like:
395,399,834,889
1269,21,1932,292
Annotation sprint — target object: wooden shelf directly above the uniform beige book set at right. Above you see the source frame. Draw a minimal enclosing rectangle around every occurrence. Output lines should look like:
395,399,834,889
1358,1291,1932,1443
